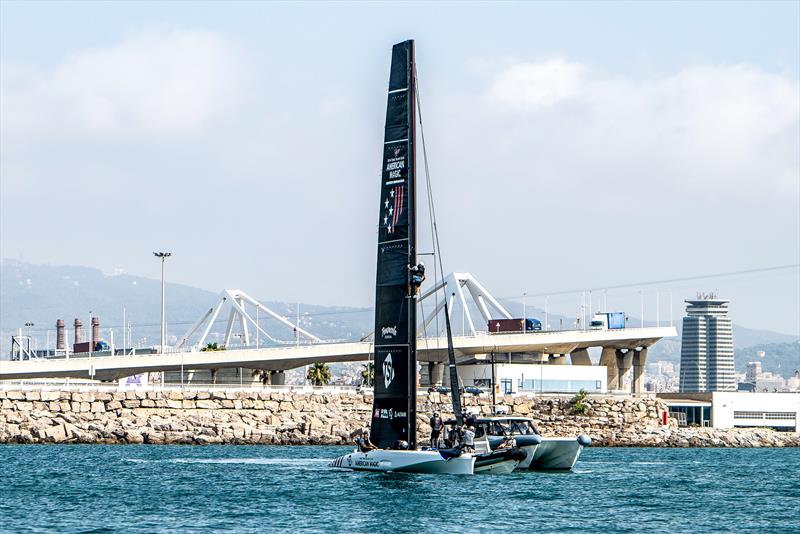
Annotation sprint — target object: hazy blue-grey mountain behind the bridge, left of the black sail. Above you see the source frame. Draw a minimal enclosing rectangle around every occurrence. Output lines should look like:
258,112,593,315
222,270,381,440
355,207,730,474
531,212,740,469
0,260,372,357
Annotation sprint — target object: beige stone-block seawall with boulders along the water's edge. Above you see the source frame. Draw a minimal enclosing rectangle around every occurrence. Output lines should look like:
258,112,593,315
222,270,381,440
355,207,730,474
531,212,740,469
0,389,800,447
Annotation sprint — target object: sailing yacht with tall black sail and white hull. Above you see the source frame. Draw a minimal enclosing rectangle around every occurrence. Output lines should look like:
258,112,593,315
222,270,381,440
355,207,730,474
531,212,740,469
330,40,475,475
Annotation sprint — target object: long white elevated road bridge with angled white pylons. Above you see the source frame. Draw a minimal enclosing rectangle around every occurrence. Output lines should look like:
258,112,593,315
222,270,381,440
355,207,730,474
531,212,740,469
0,273,677,389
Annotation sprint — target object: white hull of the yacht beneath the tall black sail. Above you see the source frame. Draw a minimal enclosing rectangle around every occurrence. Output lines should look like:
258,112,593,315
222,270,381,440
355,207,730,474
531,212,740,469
329,449,475,475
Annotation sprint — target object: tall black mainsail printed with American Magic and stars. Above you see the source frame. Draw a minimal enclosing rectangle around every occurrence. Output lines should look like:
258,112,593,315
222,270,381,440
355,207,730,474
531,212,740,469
370,40,417,449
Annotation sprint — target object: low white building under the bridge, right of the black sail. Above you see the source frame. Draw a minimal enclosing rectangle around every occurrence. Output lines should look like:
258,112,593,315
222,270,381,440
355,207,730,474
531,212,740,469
458,363,608,394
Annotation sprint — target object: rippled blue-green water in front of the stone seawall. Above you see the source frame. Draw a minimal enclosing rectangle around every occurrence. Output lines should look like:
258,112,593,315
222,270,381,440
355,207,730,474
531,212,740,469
0,445,800,534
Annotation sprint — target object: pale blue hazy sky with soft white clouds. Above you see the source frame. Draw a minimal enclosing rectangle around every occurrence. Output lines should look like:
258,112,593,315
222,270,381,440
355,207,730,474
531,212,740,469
0,1,800,334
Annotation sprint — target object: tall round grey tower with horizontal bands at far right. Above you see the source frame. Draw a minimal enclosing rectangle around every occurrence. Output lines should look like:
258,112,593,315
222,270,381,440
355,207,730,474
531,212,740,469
680,294,736,393
